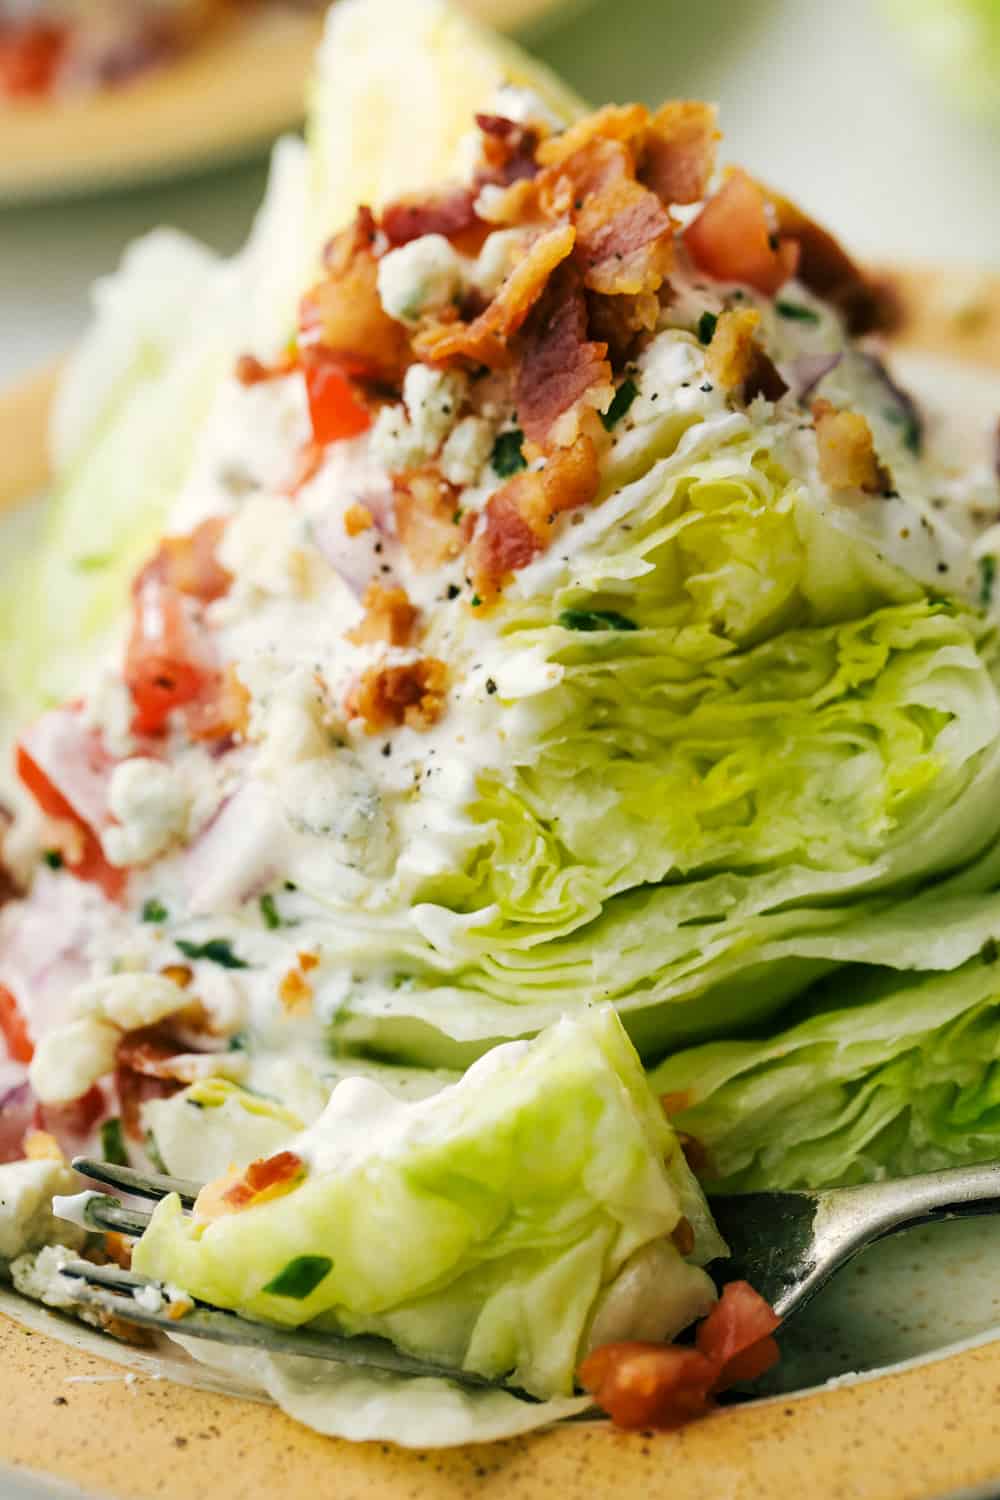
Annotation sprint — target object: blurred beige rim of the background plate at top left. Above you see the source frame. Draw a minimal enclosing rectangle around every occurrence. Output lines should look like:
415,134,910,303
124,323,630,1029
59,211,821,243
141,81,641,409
0,0,578,206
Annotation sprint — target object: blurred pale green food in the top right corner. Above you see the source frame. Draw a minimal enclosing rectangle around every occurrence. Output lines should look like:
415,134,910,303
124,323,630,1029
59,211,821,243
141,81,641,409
888,0,1000,117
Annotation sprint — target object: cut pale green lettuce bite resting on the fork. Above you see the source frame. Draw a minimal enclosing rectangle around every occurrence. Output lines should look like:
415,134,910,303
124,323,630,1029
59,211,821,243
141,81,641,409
133,1007,724,1398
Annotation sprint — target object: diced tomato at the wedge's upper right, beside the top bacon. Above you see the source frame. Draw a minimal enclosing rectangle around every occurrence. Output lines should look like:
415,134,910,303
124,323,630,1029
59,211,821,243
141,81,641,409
684,170,799,296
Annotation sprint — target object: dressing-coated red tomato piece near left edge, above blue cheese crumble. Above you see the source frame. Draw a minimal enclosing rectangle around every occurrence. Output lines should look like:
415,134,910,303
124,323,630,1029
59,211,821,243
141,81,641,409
15,705,127,902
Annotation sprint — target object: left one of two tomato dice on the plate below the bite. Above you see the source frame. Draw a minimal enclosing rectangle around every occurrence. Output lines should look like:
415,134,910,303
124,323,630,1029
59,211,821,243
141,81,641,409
579,1343,717,1431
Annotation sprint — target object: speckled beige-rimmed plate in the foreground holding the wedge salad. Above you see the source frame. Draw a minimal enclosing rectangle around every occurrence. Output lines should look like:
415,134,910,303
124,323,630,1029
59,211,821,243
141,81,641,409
0,270,1000,1500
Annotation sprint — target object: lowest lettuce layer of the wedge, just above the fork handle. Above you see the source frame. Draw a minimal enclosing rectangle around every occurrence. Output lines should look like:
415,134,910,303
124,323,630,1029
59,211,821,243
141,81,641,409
651,942,1000,1191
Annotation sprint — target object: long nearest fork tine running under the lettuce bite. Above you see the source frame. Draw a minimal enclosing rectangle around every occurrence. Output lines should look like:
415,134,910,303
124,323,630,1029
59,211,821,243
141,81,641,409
61,1260,535,1401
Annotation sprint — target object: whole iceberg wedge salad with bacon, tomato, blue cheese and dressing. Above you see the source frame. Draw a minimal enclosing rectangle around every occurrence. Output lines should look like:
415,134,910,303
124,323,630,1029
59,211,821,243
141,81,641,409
0,0,1000,1446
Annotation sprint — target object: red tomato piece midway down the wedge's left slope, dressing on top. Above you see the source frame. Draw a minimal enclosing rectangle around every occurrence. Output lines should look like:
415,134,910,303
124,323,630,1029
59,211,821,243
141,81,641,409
124,576,213,735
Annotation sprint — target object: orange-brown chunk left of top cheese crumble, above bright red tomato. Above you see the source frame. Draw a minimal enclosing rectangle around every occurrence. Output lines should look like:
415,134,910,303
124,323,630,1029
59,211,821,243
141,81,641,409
298,209,411,387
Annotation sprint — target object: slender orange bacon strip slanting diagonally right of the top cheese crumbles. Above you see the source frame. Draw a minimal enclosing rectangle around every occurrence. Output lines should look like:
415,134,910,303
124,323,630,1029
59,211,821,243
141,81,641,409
414,224,576,369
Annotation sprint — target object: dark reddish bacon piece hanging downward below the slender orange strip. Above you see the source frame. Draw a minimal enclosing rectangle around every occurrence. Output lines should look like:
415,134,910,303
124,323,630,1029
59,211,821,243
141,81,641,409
516,267,612,444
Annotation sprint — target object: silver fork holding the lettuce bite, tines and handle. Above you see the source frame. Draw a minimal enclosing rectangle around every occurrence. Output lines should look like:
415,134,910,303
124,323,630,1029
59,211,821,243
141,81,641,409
52,1157,1000,1401
